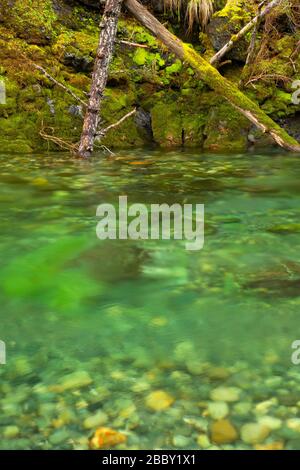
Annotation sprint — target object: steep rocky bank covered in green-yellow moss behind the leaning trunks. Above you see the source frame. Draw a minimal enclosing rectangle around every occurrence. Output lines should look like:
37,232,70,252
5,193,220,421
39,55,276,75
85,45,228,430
0,0,300,152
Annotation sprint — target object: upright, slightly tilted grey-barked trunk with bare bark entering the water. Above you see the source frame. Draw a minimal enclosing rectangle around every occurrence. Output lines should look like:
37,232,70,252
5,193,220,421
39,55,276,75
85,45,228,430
78,0,122,158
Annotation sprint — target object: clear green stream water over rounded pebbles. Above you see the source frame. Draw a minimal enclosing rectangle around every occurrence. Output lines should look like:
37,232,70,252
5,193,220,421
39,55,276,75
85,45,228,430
0,152,300,449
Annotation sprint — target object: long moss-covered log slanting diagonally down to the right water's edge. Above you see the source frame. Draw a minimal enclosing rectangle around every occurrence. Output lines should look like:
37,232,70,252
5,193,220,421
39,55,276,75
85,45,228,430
125,0,300,152
